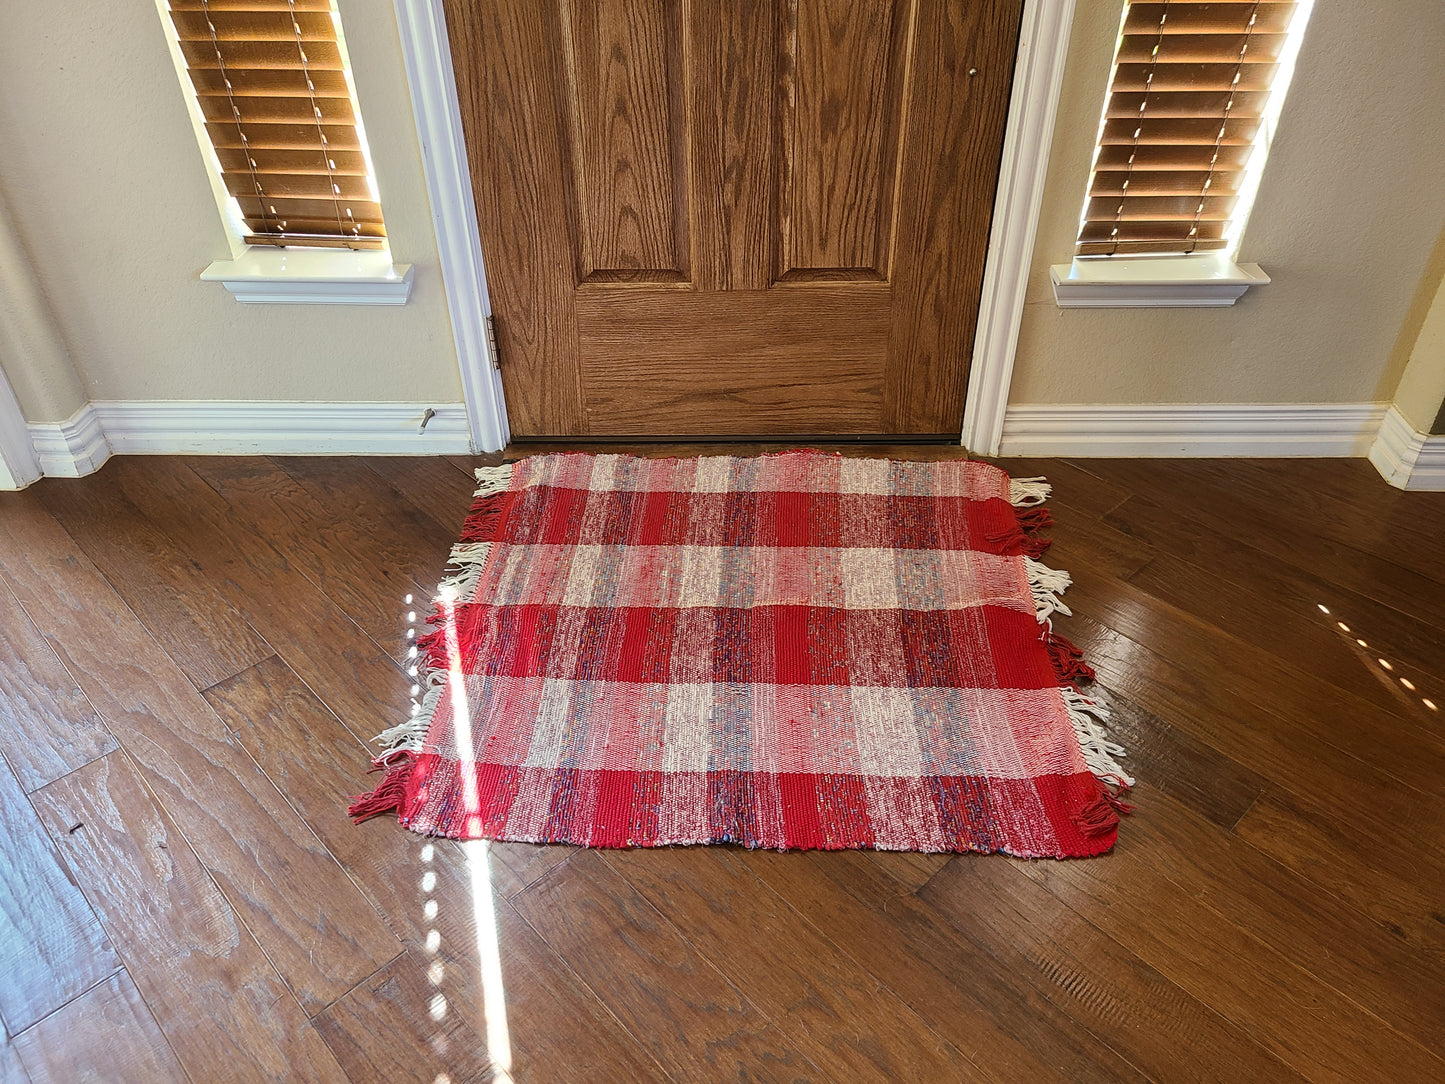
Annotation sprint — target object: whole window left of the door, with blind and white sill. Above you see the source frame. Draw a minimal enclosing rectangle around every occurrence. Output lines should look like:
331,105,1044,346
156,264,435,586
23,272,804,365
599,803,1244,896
158,0,410,304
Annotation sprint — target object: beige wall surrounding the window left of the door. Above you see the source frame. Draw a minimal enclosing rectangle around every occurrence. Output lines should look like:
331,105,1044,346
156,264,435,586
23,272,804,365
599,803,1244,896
0,0,462,422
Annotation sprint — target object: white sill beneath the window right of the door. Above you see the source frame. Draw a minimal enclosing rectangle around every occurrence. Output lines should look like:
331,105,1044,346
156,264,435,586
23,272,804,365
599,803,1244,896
1049,253,1269,309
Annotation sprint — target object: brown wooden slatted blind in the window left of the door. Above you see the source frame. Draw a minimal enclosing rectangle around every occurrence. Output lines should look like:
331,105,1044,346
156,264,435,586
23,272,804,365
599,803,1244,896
169,0,386,249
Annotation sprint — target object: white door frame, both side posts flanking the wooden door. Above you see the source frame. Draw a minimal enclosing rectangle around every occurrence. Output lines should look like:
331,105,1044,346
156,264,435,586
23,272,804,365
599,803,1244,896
394,0,1075,455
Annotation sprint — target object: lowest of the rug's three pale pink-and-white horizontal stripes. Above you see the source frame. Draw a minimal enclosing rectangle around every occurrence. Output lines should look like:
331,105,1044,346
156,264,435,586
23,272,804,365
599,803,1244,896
432,676,1085,779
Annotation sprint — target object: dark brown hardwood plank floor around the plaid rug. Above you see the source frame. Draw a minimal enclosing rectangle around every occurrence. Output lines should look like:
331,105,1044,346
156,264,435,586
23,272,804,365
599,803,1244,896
0,445,1445,1084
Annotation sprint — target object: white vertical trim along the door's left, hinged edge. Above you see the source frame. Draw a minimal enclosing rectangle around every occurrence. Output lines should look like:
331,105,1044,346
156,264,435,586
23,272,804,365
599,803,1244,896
396,0,512,451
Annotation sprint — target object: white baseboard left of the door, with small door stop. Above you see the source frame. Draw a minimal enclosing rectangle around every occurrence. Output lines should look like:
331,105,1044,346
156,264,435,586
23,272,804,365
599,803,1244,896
29,400,471,478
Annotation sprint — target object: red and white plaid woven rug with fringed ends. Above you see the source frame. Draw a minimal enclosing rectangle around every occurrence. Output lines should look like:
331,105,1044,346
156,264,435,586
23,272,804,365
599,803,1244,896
351,451,1133,857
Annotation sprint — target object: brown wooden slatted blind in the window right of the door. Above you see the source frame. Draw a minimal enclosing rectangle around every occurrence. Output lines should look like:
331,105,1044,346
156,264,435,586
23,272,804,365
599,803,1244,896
1077,0,1298,256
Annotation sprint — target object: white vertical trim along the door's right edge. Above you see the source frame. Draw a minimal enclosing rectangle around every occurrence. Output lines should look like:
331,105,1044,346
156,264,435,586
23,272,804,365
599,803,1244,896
962,0,1074,455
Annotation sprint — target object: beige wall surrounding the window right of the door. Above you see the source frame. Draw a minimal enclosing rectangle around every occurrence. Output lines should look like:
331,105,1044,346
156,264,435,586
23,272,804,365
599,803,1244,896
1010,0,1445,403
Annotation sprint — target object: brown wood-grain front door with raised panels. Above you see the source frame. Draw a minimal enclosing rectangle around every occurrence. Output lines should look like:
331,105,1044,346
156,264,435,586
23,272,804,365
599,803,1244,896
447,0,1022,438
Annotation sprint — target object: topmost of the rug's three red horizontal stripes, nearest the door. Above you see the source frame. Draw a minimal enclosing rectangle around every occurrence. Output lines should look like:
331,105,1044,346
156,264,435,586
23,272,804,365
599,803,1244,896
496,486,1029,554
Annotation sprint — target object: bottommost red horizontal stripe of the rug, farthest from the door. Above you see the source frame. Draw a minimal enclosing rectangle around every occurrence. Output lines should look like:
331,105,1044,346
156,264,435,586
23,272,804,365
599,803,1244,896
403,754,1117,857
